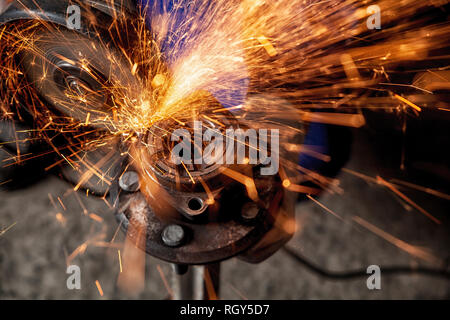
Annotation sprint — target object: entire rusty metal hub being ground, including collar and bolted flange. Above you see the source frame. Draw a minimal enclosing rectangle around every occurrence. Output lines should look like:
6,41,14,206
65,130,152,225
110,93,294,265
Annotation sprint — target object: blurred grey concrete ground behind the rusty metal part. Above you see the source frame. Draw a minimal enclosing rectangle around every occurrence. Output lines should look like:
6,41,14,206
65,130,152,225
0,129,450,299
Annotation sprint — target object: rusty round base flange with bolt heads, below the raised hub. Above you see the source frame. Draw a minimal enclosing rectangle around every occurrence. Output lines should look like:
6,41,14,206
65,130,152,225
110,162,282,265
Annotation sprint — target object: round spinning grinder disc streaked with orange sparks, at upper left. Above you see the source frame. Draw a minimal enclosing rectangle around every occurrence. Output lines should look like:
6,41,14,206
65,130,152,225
21,28,139,126
